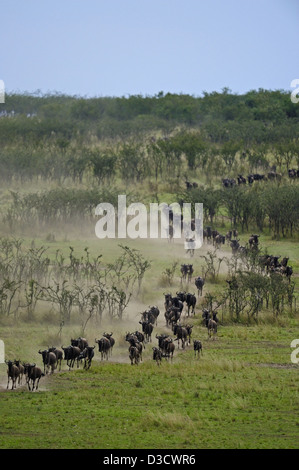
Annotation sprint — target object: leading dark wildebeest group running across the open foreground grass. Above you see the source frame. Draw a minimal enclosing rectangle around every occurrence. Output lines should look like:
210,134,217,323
6,265,213,391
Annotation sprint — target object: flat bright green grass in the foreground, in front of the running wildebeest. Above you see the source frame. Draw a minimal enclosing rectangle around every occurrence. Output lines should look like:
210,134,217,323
0,323,299,449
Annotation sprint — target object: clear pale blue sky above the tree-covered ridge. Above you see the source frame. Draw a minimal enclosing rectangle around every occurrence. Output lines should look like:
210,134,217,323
0,0,299,97
